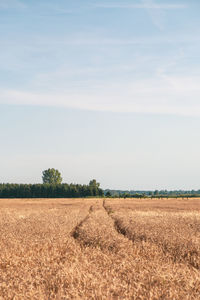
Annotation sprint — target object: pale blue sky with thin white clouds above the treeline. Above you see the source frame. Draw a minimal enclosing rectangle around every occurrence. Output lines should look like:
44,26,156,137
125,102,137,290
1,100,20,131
0,0,200,190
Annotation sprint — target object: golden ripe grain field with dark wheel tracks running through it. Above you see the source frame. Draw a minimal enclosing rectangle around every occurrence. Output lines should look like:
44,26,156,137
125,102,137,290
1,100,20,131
0,199,200,300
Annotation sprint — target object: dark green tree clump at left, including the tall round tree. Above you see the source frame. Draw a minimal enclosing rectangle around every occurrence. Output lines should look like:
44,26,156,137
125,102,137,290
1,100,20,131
0,169,104,198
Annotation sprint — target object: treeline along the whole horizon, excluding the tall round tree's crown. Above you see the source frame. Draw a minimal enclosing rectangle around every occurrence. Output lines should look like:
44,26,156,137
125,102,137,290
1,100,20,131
0,180,200,198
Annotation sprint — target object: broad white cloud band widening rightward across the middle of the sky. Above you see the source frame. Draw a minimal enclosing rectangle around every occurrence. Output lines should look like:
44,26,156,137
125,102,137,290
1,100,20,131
0,75,200,116
